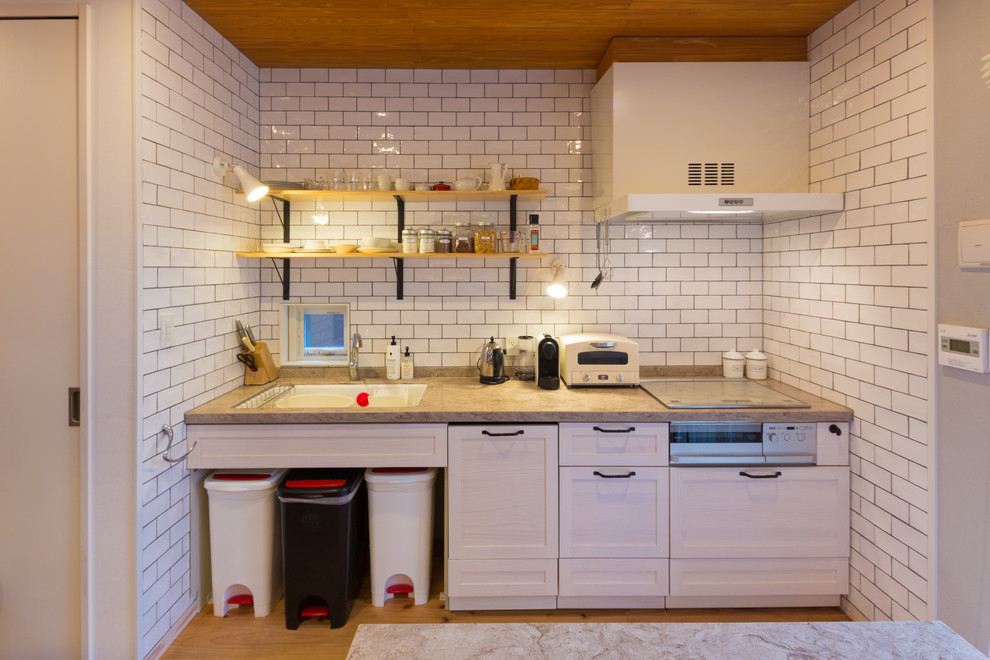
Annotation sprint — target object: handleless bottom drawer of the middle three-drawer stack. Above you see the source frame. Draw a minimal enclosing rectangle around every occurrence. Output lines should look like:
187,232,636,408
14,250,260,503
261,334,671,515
558,559,669,596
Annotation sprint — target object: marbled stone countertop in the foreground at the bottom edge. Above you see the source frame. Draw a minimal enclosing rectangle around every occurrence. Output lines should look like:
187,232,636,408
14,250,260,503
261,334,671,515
347,621,986,660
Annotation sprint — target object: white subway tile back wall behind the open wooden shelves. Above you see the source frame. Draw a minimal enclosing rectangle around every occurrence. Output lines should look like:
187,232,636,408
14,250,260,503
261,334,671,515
260,69,763,369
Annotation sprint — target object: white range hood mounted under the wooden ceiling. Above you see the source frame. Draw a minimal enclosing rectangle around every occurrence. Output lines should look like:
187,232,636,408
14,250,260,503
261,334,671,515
591,62,843,222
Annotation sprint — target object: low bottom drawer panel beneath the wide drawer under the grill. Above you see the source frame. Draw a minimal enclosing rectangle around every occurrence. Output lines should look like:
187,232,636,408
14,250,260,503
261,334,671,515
670,557,849,596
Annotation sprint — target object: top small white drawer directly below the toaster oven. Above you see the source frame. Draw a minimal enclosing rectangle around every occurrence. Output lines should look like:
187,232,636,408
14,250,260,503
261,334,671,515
560,422,668,465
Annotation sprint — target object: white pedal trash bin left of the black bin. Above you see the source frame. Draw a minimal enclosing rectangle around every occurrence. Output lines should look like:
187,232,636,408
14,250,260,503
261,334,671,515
205,470,286,617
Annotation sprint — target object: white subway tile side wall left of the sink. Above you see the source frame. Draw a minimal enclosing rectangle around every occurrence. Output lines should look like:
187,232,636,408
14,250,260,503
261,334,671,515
138,0,261,657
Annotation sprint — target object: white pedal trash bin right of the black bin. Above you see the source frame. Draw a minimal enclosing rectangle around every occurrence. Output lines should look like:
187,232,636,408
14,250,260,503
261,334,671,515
364,468,437,607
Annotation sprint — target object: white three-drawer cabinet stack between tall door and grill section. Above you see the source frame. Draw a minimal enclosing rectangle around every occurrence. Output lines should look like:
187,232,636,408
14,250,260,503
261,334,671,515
557,423,670,608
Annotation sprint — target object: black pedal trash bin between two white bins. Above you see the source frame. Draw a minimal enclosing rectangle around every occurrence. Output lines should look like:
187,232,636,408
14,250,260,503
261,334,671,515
278,468,368,630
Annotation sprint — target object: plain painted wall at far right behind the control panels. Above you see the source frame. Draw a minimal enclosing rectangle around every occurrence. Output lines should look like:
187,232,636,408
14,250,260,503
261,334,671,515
935,0,990,652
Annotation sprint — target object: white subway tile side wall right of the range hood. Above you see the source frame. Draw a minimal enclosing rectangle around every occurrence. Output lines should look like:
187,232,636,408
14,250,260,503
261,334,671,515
764,0,933,621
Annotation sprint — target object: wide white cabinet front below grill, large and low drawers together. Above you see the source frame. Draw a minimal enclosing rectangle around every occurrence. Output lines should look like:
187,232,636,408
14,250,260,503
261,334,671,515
667,466,849,607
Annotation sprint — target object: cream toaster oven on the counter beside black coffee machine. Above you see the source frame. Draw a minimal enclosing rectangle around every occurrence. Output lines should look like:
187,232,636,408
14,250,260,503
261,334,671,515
559,333,639,387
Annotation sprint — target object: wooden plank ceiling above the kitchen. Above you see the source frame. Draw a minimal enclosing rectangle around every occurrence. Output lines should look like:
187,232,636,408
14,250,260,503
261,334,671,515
185,0,852,69
